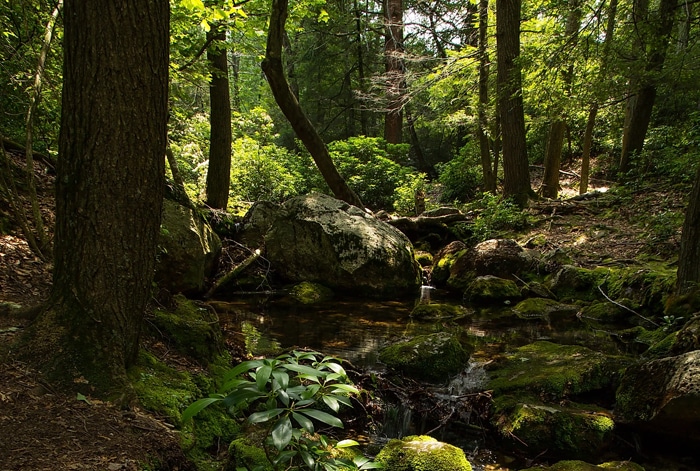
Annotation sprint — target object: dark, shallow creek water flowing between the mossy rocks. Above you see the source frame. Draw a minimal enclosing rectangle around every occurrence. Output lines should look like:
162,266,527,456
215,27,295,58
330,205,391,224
211,289,696,471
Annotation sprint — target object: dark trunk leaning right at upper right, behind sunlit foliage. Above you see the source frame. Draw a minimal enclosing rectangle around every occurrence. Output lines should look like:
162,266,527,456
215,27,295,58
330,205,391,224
619,0,677,174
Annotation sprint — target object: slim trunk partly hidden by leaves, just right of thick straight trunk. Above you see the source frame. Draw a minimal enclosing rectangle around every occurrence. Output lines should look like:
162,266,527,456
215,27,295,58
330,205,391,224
541,0,581,198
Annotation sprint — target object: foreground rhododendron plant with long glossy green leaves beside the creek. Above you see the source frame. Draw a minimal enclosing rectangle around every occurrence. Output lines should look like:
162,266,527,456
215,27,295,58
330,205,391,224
183,351,375,471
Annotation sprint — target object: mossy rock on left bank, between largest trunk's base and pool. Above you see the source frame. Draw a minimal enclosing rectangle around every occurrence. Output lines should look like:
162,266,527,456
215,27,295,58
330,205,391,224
152,295,223,365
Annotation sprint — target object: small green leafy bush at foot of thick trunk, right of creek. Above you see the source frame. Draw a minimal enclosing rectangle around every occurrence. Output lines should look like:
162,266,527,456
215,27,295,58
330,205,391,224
469,193,529,242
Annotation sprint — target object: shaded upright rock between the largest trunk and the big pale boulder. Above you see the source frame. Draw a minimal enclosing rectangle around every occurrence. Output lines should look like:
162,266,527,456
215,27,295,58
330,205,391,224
155,199,221,294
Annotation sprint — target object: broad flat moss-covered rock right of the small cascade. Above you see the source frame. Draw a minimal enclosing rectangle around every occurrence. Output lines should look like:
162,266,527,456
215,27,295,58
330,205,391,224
487,341,627,400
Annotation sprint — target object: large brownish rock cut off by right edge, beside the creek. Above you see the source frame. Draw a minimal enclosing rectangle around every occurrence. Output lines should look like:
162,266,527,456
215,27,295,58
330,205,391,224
615,350,700,441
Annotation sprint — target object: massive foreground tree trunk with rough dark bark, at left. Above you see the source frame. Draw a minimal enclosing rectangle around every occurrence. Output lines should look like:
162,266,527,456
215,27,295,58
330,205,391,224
28,0,169,394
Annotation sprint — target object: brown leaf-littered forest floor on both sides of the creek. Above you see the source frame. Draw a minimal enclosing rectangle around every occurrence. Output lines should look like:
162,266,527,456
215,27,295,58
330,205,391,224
0,148,689,471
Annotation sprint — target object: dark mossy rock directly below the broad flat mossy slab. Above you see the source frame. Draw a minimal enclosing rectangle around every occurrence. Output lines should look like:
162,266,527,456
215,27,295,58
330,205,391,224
491,396,615,458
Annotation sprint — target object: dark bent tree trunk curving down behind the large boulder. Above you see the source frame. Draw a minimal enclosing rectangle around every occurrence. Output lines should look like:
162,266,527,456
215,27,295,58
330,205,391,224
262,0,364,208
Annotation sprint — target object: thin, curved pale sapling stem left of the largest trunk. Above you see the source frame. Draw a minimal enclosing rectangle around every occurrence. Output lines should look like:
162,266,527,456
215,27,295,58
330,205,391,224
24,0,63,259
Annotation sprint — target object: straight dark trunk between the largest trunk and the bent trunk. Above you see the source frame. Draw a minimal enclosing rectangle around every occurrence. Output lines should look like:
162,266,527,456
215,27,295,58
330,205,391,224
206,26,231,209
